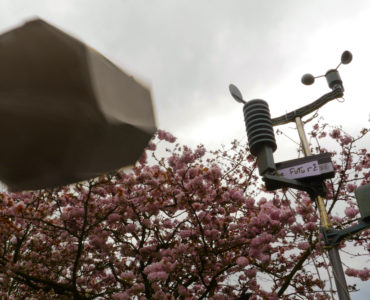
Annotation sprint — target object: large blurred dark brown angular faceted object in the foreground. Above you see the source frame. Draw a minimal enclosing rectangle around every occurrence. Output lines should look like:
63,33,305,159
0,19,156,190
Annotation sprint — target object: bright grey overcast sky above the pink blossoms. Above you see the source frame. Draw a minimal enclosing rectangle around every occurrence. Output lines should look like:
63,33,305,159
0,0,370,299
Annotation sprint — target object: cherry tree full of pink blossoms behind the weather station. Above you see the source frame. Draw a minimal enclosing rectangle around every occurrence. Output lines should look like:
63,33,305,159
0,122,370,300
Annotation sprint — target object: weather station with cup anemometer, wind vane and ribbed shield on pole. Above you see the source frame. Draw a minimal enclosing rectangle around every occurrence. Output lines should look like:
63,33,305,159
229,51,370,300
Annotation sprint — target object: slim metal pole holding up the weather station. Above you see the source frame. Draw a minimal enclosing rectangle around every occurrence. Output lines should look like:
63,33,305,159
295,117,351,300
